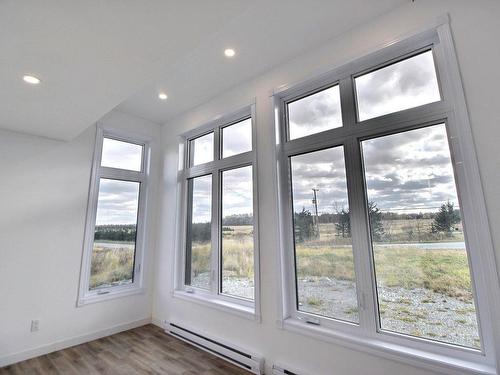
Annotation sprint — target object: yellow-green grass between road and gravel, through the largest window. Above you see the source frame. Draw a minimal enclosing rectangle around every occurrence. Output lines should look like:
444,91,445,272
296,245,472,300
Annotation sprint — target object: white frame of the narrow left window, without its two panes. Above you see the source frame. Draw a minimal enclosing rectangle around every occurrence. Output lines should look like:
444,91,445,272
77,123,151,306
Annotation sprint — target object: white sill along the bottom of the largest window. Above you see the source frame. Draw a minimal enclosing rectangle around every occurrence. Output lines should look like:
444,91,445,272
281,318,497,375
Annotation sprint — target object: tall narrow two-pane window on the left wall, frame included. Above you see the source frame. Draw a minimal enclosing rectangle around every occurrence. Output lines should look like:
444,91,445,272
79,128,149,304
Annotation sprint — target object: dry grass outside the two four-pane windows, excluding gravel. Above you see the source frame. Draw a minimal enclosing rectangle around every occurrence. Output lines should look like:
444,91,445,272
188,223,471,299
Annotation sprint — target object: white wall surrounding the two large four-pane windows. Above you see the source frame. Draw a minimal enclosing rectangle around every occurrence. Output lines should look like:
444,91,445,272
153,0,500,375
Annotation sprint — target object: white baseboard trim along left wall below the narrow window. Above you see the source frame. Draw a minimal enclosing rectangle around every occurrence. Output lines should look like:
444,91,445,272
0,318,151,368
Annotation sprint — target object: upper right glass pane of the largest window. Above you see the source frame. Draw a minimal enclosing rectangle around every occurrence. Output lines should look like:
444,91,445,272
355,51,441,121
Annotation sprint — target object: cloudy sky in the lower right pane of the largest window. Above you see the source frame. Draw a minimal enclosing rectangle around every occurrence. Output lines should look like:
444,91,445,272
362,124,458,212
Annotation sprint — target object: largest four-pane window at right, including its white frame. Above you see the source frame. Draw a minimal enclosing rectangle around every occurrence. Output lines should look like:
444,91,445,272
275,24,495,374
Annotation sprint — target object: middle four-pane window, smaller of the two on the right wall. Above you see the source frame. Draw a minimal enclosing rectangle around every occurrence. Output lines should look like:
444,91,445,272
177,108,258,310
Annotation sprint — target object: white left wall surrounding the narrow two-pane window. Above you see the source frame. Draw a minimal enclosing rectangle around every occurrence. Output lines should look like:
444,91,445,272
0,112,160,367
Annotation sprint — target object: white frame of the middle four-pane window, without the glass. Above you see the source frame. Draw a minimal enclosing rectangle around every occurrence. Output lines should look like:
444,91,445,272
173,104,260,321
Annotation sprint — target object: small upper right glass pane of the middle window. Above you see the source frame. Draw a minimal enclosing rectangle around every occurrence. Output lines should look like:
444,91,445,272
222,119,252,158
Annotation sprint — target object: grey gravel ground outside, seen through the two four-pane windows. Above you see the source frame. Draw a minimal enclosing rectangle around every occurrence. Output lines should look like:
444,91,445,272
192,274,480,348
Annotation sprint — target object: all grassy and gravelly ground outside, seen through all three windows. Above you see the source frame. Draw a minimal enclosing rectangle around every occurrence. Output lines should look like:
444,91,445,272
91,219,480,347
